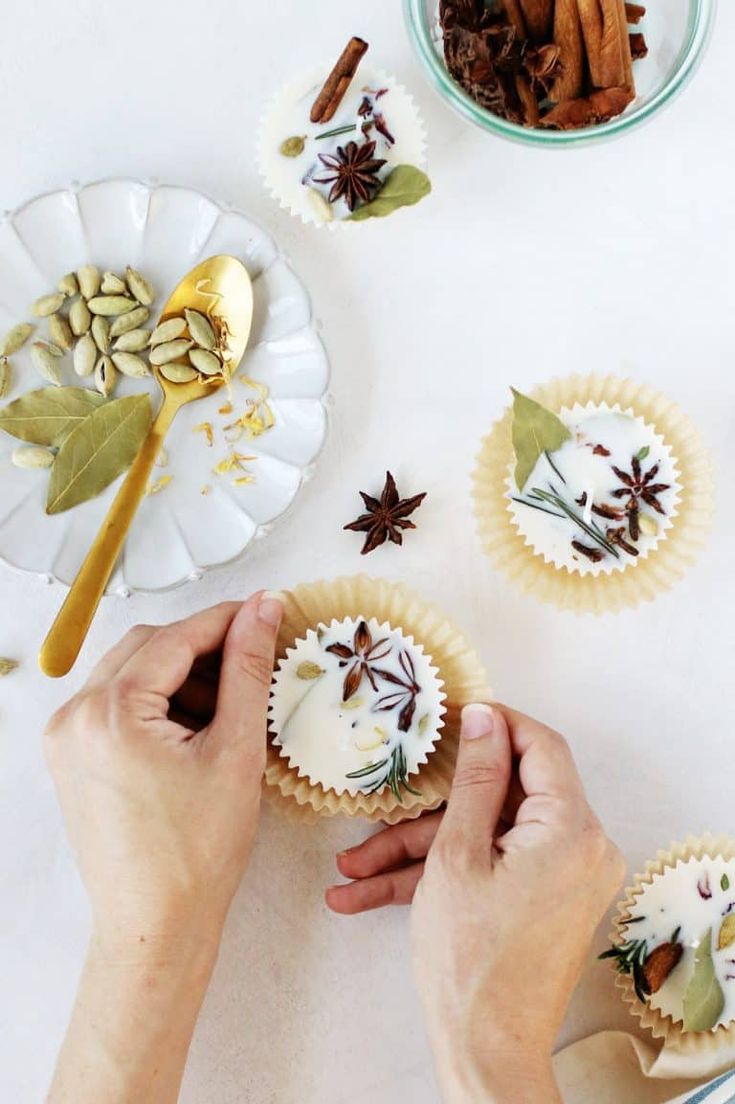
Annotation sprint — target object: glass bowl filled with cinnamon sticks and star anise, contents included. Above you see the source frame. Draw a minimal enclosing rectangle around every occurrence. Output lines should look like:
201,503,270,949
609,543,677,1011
403,0,716,146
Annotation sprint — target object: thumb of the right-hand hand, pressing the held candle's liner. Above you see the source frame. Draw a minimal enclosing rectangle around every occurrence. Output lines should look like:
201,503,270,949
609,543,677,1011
439,703,511,854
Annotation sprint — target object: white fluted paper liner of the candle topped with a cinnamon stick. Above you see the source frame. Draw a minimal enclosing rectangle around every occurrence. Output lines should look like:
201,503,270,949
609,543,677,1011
256,66,426,230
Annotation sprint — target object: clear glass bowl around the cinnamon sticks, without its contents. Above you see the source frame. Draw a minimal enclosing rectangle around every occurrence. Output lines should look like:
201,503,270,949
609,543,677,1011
403,0,716,147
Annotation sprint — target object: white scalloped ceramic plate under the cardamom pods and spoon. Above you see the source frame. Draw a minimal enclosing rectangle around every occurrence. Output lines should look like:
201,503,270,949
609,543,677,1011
0,180,329,595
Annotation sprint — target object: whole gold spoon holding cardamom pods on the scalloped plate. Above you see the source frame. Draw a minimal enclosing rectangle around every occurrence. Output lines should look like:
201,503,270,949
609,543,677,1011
39,256,253,678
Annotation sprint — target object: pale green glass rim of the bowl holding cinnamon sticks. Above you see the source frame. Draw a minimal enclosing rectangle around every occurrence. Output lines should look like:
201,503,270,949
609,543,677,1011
403,0,717,148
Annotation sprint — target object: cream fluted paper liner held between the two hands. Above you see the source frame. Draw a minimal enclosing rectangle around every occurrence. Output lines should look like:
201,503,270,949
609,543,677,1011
260,575,492,824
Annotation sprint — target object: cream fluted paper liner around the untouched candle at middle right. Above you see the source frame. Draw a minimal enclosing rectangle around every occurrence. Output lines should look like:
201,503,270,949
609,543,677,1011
465,375,714,614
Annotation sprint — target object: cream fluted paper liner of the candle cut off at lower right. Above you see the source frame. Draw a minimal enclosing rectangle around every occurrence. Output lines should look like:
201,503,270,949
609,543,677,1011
610,835,735,1068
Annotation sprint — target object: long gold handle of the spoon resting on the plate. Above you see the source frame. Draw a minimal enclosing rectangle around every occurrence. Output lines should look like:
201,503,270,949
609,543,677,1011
39,399,179,678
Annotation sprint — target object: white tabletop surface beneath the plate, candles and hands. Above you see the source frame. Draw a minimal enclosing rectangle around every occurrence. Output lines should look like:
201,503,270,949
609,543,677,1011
0,0,735,1104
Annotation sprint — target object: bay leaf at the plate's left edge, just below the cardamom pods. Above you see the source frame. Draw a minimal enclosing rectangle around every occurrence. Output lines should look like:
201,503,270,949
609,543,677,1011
0,388,105,448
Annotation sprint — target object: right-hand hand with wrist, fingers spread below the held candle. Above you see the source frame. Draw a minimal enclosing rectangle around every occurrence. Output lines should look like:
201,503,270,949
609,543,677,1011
327,707,624,1104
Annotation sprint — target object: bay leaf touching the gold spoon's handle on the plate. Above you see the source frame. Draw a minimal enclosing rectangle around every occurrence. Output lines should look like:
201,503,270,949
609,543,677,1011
46,395,151,513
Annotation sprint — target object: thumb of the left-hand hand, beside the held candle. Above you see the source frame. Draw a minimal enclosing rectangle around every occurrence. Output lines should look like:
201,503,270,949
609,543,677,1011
211,591,284,747
